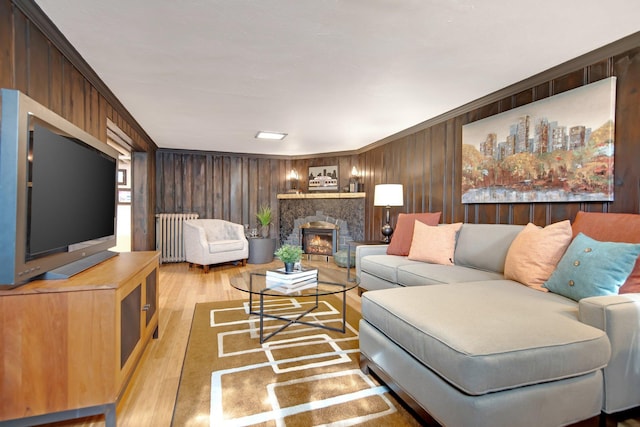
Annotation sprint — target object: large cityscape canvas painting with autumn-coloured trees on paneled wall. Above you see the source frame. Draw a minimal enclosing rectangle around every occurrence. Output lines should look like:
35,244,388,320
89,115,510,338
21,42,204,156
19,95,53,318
462,77,616,203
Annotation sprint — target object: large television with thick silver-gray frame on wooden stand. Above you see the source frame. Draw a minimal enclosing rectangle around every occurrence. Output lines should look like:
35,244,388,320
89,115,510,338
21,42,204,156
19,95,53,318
0,89,118,287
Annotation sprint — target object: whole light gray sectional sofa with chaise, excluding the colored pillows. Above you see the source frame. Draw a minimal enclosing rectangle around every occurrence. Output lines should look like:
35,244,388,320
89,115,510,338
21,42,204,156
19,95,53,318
356,224,640,427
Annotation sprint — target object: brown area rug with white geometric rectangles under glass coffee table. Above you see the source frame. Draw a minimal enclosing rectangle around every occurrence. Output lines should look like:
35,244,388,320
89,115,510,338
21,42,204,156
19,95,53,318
172,296,420,427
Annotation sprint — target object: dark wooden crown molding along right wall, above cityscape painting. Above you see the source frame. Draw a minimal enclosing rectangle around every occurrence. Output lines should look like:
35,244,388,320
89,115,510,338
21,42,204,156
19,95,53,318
356,31,640,154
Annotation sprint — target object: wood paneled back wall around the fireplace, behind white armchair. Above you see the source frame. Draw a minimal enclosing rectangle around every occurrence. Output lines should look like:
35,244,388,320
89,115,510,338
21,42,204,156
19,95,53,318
156,149,357,236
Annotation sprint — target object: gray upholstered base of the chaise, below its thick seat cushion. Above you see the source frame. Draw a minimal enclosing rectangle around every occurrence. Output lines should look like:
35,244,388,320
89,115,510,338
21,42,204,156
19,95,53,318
360,323,602,427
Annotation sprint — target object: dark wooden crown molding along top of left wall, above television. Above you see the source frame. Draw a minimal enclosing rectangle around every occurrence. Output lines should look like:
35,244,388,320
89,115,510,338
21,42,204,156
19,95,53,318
11,0,158,149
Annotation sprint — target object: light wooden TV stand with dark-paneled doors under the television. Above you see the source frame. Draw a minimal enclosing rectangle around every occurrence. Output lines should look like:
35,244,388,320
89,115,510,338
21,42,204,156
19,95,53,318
0,252,159,427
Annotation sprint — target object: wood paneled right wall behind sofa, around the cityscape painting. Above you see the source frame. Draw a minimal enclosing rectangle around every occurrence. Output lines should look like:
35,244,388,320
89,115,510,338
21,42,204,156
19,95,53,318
359,42,640,238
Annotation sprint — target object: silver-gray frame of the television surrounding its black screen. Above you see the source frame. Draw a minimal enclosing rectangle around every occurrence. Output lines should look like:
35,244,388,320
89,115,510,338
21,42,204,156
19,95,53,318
0,89,118,288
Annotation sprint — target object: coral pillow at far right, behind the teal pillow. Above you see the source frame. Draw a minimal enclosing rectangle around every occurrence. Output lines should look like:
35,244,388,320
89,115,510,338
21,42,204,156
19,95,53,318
572,211,640,294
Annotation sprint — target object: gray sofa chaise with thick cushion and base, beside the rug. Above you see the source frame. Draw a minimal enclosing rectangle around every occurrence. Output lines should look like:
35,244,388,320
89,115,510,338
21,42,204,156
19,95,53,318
360,280,610,426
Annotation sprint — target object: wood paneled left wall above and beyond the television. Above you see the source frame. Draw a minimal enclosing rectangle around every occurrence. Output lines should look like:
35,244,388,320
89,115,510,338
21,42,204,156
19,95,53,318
0,0,157,250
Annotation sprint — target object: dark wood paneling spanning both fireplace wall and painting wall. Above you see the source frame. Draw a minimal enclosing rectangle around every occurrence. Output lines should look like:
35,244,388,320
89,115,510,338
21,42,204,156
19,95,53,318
156,34,640,244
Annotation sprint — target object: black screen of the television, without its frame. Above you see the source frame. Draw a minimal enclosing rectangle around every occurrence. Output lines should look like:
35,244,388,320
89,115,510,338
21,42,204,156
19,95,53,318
26,124,117,259
